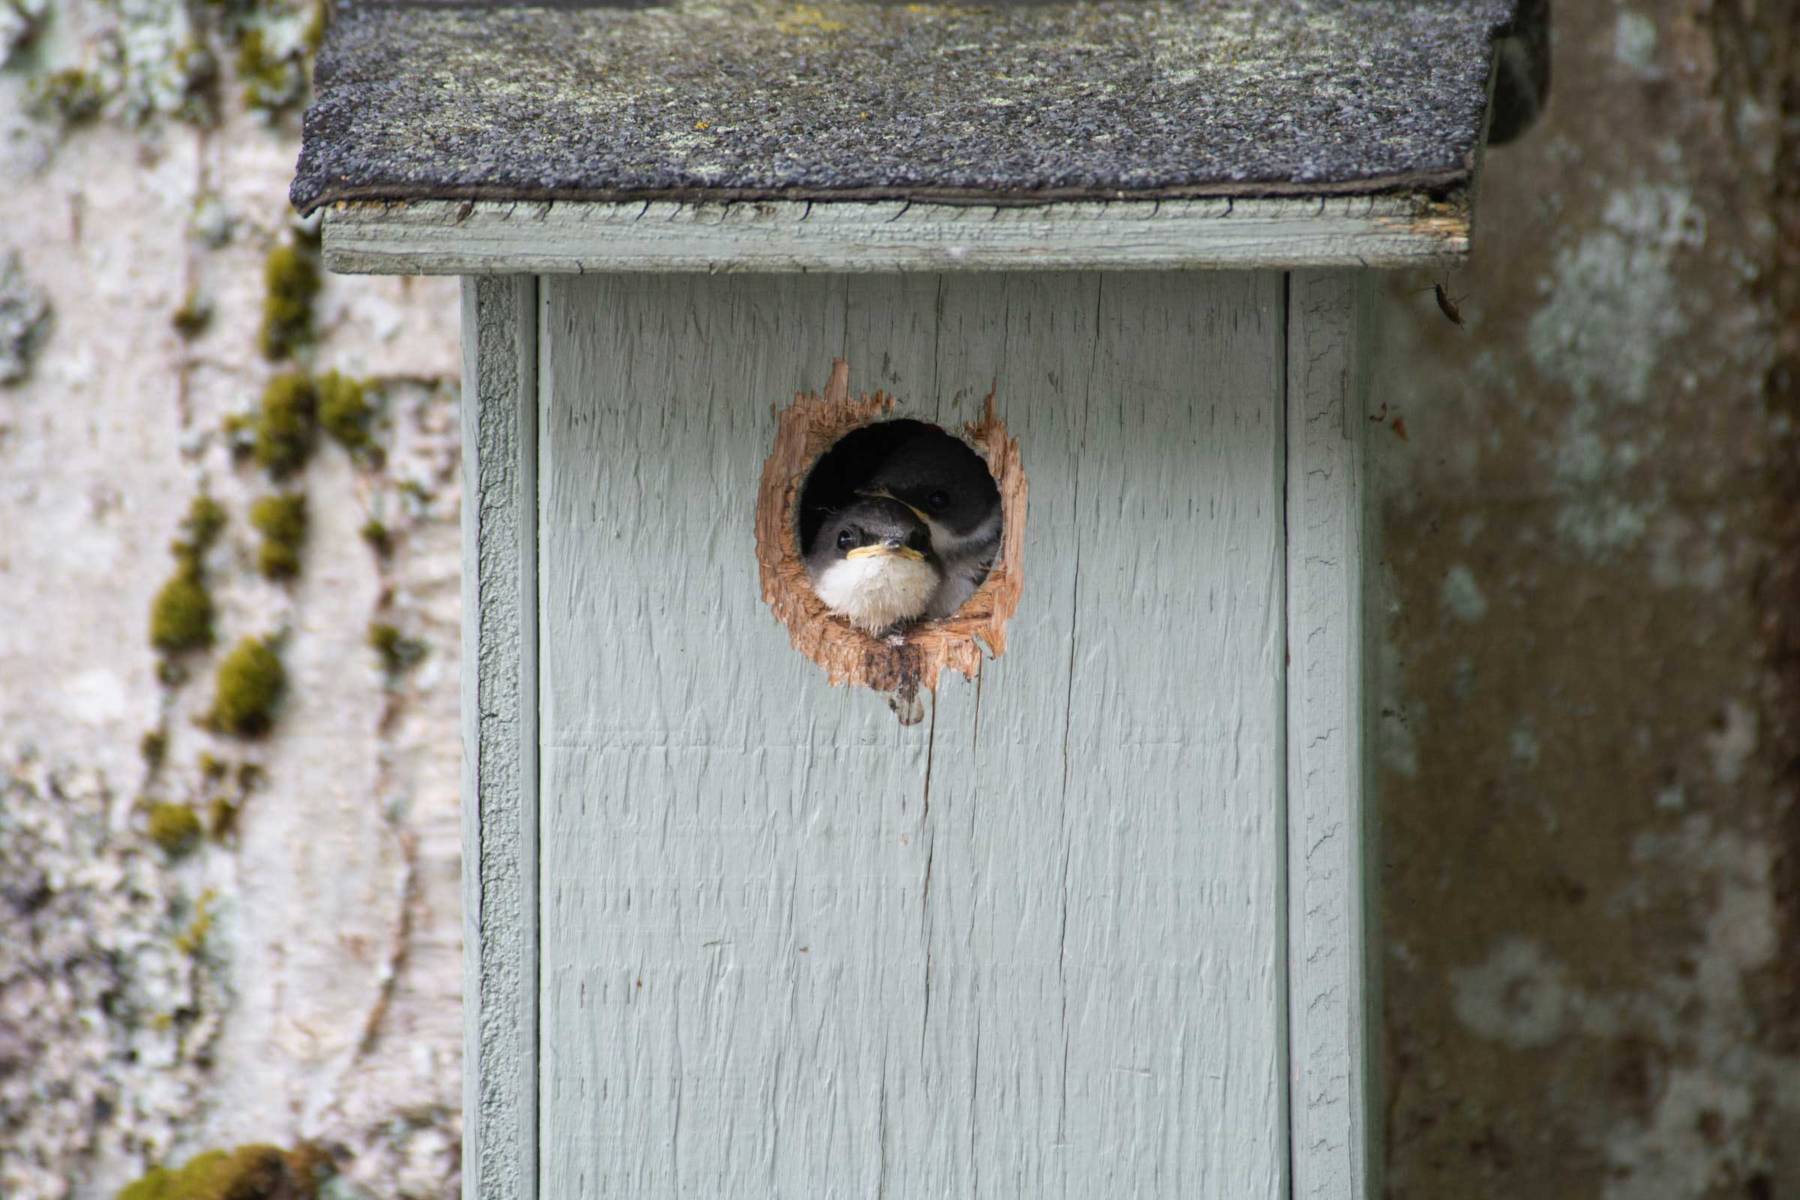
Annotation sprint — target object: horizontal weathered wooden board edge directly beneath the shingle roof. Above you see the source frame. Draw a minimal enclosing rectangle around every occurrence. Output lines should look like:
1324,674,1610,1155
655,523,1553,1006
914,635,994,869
324,194,1472,278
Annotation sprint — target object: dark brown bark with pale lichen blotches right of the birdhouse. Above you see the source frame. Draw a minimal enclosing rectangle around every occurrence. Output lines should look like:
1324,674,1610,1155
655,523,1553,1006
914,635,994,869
1370,0,1800,1200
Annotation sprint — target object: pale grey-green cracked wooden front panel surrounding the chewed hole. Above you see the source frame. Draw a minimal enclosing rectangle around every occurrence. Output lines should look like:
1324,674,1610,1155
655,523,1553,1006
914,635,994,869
540,272,1289,1200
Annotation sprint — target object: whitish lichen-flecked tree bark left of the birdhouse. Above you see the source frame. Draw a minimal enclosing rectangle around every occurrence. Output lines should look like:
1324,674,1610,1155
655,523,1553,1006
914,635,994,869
0,0,461,1200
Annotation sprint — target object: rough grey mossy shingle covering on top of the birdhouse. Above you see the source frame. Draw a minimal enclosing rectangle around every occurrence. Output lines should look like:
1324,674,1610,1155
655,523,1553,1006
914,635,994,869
292,0,1548,271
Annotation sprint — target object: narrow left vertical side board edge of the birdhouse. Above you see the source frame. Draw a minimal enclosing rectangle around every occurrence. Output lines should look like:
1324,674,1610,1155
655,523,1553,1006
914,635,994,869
463,277,538,1200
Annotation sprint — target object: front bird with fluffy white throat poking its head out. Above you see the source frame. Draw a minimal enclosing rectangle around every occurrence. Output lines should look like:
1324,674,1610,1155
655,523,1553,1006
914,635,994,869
806,497,943,637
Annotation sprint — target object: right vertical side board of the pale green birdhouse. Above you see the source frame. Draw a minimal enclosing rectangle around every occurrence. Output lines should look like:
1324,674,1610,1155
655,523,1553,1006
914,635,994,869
1287,272,1381,1200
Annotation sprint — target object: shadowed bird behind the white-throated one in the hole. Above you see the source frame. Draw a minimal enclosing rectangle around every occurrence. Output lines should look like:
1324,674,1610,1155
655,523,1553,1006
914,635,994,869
857,430,1001,621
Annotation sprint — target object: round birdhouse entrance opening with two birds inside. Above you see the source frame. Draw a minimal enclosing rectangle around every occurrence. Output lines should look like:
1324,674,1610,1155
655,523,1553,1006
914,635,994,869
799,419,1001,637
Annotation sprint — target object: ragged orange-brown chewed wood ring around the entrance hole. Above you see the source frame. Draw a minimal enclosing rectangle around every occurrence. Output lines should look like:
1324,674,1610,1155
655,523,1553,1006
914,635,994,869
756,358,1026,720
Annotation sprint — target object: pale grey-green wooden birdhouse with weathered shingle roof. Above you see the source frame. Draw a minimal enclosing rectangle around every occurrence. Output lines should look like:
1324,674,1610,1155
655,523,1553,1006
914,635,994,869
293,0,1535,1200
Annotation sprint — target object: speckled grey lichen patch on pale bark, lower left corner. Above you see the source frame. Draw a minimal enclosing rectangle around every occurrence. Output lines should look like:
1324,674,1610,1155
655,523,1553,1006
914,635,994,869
0,759,227,1200
